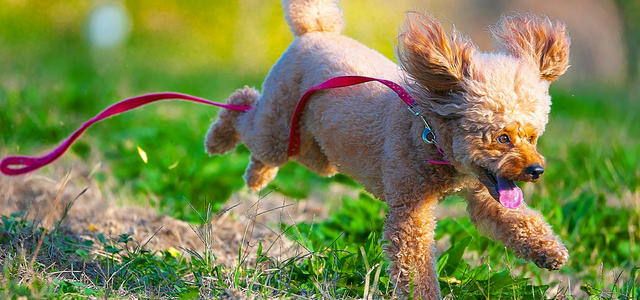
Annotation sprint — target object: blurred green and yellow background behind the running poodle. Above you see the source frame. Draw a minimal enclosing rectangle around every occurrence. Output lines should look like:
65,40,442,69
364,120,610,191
0,0,640,296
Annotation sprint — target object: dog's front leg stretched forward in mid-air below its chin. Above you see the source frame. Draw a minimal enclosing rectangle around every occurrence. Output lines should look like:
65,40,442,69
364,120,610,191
465,187,569,270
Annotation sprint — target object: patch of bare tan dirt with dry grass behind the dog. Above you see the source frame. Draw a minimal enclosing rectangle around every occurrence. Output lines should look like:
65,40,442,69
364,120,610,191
0,158,327,266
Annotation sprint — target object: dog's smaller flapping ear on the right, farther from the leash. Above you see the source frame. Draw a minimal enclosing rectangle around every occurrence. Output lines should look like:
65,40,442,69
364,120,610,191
491,12,571,82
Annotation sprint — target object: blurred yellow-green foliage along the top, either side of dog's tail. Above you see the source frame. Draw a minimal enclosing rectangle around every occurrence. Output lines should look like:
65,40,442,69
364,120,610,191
0,0,410,73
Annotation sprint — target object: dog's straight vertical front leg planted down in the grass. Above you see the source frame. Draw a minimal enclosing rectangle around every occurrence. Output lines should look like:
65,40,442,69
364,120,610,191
384,197,440,299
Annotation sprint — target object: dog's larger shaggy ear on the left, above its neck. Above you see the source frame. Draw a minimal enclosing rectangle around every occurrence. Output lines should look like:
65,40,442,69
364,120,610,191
396,12,476,94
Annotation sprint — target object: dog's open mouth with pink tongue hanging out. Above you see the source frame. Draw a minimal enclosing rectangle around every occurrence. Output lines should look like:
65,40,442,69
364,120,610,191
478,168,524,208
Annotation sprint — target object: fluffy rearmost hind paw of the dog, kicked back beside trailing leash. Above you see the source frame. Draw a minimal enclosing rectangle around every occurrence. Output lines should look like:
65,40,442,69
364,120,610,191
204,86,260,155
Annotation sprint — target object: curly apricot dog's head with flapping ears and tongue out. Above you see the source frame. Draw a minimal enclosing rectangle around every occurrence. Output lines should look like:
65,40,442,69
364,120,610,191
397,12,570,208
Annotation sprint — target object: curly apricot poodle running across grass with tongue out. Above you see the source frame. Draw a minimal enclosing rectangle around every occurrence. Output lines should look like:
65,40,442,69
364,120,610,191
205,0,570,299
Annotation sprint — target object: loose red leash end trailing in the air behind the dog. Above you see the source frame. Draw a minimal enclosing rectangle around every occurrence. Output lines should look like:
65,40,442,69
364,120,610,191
0,93,253,175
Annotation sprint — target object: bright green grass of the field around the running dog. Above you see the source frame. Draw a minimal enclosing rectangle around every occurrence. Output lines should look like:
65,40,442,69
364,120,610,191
0,2,640,299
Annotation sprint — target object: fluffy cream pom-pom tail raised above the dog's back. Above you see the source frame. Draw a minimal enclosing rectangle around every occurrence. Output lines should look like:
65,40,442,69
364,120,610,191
283,0,344,36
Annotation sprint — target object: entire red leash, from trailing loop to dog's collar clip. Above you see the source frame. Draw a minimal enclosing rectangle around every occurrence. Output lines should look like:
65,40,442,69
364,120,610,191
0,76,450,175
